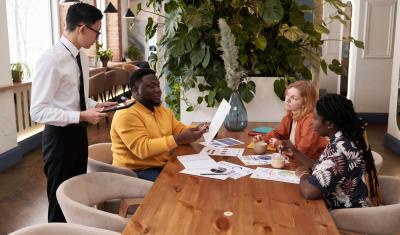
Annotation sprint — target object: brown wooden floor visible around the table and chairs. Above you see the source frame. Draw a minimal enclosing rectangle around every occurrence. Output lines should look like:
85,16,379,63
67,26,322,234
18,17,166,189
0,119,400,234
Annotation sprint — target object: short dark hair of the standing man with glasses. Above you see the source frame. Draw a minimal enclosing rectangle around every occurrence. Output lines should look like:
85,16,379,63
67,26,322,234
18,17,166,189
66,2,103,32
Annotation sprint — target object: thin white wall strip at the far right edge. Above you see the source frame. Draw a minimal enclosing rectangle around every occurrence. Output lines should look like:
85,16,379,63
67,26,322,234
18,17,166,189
387,0,400,140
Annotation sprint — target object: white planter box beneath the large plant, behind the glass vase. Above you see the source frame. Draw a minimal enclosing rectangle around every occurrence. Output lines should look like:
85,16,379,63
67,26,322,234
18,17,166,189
181,77,285,124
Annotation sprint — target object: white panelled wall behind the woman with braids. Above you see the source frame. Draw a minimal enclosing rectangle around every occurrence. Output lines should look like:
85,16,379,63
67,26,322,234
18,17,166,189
348,0,396,113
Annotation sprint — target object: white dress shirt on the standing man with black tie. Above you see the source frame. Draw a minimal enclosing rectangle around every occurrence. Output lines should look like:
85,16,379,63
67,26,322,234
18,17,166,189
30,36,97,126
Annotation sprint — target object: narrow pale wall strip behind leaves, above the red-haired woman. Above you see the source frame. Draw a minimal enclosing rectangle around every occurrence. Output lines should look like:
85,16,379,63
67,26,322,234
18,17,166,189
319,4,341,93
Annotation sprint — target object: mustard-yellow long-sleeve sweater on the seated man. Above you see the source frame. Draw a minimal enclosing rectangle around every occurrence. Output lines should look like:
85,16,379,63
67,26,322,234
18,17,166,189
110,101,189,170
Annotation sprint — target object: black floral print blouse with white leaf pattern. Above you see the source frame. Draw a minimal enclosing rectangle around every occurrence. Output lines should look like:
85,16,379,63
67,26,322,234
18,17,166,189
308,131,370,209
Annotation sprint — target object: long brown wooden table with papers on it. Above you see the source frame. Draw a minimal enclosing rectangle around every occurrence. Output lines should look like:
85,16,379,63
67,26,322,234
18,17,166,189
122,123,339,235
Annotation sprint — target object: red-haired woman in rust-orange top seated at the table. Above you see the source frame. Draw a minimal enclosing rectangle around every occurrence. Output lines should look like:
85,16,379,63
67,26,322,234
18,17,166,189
255,80,328,159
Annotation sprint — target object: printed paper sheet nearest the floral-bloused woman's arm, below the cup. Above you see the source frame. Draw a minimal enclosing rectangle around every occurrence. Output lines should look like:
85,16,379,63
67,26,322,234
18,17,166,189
250,167,300,184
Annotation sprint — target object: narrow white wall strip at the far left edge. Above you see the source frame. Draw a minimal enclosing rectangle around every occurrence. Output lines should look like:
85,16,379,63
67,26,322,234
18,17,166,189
0,1,17,154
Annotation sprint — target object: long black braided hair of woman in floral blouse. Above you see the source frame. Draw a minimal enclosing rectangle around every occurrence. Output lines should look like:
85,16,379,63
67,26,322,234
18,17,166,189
316,94,381,205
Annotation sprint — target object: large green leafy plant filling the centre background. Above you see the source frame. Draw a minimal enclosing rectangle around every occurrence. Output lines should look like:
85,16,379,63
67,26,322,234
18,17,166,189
137,0,363,116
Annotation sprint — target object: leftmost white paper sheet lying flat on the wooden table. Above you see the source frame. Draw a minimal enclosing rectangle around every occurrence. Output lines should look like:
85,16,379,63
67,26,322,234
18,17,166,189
177,154,218,170
